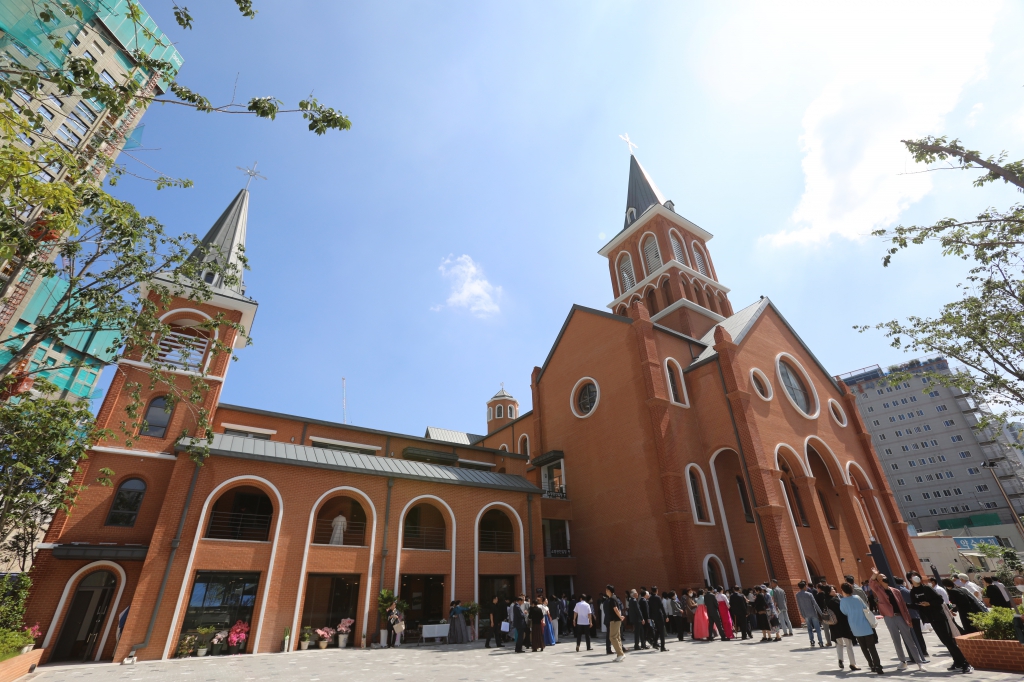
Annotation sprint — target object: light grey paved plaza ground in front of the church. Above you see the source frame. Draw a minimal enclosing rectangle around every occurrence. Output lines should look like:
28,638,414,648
23,628,1021,682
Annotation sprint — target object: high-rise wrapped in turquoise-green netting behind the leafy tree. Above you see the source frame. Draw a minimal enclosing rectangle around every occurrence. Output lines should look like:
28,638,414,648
0,0,182,399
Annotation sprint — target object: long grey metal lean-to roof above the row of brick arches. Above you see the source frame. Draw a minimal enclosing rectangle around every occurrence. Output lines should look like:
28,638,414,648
175,433,541,493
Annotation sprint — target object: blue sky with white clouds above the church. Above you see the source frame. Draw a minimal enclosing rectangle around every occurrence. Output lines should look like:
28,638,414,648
105,0,1024,434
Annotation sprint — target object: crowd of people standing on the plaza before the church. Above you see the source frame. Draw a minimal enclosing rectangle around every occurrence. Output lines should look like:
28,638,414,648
466,568,1024,675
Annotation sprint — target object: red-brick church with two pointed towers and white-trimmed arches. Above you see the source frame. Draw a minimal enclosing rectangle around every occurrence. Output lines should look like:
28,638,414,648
27,152,918,662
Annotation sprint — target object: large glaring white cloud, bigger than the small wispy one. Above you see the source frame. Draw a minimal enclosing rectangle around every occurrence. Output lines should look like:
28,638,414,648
706,0,998,245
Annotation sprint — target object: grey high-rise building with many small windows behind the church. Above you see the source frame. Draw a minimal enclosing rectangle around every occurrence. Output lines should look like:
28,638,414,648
841,357,1024,530
